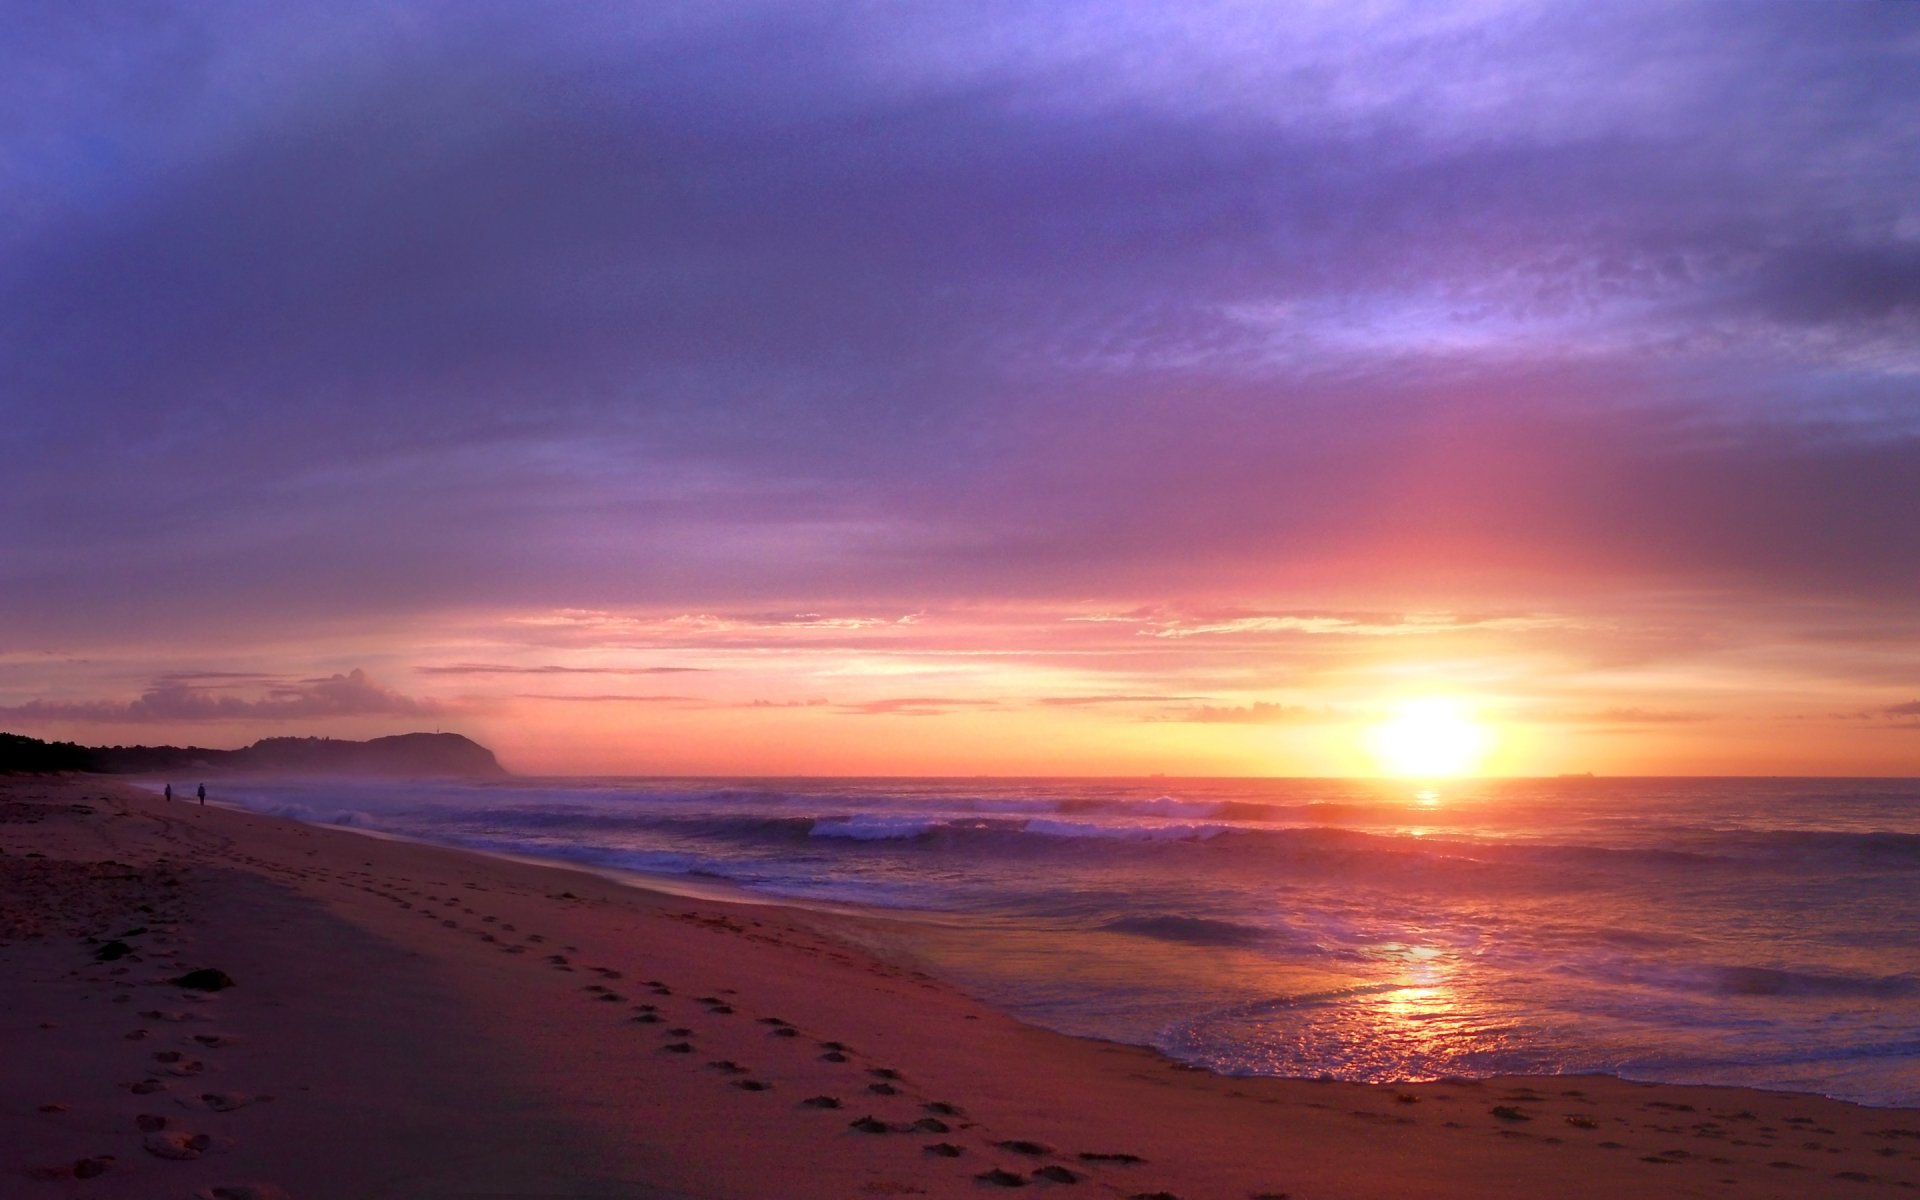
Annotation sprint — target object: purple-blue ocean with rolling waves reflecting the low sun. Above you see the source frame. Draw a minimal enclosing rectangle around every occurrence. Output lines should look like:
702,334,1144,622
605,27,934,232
194,778,1920,1106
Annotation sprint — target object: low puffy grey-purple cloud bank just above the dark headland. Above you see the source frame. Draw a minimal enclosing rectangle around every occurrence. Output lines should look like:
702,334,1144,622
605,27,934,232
0,670,455,724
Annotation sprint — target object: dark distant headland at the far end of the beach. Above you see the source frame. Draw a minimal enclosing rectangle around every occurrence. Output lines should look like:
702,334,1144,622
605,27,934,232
0,733,507,780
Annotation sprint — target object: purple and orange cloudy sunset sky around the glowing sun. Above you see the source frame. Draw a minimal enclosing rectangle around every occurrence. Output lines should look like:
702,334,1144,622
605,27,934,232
0,0,1920,776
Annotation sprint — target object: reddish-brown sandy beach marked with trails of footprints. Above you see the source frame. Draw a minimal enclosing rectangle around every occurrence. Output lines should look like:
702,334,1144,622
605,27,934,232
0,776,1920,1200
